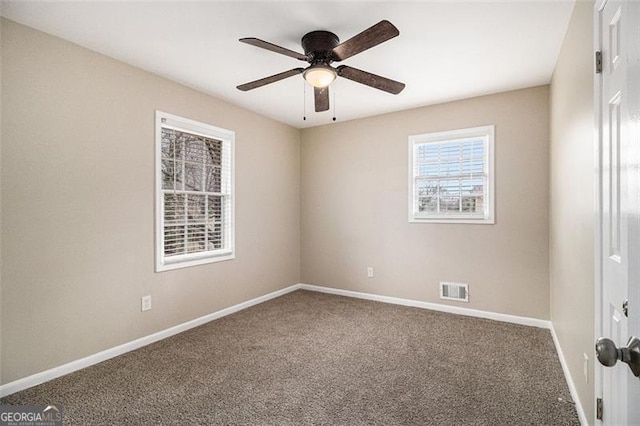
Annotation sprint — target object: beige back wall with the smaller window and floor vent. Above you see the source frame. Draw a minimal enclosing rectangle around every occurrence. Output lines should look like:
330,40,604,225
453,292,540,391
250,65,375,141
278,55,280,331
301,86,549,319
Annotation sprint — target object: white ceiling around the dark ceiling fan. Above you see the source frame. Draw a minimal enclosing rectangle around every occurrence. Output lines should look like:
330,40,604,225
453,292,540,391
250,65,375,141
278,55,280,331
1,0,573,128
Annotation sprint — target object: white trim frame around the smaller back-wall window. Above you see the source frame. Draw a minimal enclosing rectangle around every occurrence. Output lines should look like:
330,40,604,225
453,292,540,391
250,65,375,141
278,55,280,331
408,125,495,225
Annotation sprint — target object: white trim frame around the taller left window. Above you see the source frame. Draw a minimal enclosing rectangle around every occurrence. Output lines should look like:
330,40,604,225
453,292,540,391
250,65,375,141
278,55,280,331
155,110,236,272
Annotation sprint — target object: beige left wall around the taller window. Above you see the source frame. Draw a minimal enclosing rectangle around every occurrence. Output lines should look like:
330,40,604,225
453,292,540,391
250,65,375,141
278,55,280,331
1,21,300,383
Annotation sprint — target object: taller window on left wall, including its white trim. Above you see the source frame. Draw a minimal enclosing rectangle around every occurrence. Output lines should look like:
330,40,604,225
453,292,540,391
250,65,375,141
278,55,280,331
156,111,235,271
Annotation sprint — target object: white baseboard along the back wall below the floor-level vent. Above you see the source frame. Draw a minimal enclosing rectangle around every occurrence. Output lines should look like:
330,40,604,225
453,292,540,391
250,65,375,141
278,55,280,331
298,284,551,329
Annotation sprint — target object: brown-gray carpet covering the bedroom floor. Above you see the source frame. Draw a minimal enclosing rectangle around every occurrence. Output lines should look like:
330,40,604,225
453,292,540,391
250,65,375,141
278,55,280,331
1,291,579,425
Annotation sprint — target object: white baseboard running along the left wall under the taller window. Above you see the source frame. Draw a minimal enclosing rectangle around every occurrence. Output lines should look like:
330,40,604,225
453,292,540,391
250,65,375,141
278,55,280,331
0,284,300,397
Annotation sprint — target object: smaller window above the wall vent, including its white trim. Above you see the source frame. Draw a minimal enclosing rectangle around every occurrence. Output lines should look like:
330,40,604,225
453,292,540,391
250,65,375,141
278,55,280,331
409,126,495,224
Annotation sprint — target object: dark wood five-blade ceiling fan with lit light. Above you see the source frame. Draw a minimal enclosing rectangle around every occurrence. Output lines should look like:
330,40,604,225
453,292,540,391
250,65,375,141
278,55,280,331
238,20,405,112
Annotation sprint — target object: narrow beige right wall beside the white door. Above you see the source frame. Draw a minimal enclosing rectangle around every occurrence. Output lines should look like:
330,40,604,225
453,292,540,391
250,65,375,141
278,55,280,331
549,1,595,423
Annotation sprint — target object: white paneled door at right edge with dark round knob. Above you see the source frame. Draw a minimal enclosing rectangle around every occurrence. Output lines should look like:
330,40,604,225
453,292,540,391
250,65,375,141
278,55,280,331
596,0,640,425
